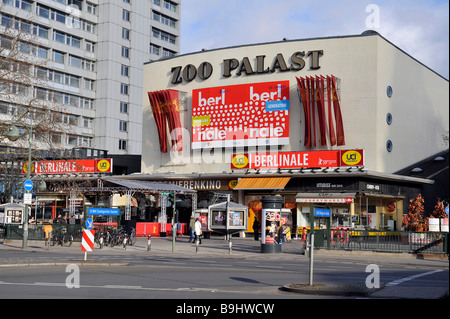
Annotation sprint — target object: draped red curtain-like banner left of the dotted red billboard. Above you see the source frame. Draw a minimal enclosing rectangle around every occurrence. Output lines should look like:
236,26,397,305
148,90,183,153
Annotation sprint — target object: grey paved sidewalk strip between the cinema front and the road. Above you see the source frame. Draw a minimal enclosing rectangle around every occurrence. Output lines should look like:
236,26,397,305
0,236,449,268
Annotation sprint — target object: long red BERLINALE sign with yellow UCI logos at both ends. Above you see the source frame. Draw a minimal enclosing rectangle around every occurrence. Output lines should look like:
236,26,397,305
231,150,364,169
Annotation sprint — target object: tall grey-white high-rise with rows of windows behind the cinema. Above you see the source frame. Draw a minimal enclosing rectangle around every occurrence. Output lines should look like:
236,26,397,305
0,0,181,170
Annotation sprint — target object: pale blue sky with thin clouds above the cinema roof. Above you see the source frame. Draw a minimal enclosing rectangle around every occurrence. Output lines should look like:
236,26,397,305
181,0,449,79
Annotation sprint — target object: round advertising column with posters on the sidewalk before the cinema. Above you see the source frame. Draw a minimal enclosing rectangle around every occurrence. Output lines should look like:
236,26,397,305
261,196,283,253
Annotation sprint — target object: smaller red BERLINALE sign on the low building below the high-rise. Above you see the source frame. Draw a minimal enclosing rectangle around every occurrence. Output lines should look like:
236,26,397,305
22,158,112,174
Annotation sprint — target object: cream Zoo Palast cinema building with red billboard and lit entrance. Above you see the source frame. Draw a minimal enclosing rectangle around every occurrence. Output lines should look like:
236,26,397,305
122,32,449,232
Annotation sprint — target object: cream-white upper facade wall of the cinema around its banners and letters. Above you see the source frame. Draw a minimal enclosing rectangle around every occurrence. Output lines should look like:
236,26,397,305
142,34,449,174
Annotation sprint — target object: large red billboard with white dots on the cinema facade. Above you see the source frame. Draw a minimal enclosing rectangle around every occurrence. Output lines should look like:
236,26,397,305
192,81,289,149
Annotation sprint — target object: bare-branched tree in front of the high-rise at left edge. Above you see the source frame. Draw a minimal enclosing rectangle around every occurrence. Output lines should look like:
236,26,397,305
0,2,70,202
